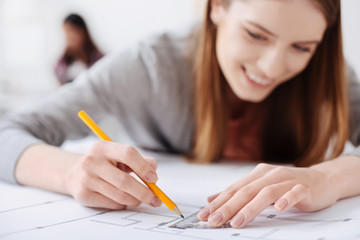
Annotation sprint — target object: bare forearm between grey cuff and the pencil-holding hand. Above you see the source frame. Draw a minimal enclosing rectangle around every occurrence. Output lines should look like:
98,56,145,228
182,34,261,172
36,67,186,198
15,144,81,194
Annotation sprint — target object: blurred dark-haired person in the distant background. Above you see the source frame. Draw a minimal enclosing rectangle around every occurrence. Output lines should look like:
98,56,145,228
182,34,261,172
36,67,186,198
55,14,103,85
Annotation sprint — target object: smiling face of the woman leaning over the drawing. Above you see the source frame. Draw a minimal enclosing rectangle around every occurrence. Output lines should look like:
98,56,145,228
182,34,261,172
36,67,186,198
211,0,327,102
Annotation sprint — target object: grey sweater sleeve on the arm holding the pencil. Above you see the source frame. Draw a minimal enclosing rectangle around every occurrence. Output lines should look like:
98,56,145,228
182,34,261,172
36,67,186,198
0,46,151,183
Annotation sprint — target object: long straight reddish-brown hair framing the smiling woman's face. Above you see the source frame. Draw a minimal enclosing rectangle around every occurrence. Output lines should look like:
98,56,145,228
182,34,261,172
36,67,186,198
190,0,348,166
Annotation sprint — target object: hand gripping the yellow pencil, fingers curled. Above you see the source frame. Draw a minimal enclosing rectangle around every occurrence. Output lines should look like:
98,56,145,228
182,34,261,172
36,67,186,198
66,141,161,209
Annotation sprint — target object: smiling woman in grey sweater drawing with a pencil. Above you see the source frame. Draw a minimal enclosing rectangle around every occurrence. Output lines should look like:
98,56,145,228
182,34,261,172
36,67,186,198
0,0,360,228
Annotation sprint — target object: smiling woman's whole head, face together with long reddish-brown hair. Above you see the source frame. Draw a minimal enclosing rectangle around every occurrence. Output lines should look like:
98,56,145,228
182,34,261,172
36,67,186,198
194,1,348,166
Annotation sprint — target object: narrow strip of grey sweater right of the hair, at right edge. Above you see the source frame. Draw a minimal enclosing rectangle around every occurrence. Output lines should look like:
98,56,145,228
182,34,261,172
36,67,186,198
348,67,360,156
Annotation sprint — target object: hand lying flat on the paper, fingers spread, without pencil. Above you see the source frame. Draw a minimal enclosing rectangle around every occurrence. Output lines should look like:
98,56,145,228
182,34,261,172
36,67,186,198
198,163,339,228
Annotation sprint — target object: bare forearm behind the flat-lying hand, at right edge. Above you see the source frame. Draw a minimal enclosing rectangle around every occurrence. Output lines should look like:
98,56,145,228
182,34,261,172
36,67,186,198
311,155,360,199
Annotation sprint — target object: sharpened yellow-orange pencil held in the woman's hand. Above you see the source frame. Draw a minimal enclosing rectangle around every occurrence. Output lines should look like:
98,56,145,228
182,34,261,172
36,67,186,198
78,111,184,218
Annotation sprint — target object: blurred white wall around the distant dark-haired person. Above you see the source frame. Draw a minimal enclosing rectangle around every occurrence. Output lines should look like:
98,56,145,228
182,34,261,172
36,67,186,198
0,0,204,112
